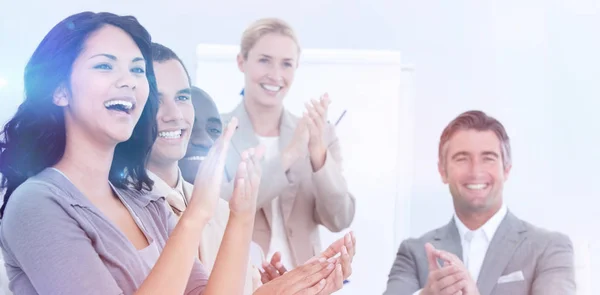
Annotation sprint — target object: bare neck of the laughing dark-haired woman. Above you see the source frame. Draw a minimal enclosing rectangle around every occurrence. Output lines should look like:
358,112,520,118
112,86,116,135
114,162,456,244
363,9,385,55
54,128,116,199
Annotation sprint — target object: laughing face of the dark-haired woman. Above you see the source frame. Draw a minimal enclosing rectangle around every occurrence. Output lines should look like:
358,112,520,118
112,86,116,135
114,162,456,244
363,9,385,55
54,25,150,145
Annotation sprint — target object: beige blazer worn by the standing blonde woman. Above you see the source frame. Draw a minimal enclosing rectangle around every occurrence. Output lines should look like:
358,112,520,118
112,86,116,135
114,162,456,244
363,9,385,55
221,102,355,267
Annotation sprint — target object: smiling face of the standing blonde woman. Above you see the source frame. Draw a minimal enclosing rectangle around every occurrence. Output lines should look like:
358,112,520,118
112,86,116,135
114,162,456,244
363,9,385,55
238,33,299,107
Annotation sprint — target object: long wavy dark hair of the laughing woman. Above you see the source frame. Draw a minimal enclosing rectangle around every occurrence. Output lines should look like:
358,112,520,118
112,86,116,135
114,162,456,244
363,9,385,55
0,12,158,218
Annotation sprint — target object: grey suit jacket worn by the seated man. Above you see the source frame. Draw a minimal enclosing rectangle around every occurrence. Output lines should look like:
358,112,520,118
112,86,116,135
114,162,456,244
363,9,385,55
384,212,575,295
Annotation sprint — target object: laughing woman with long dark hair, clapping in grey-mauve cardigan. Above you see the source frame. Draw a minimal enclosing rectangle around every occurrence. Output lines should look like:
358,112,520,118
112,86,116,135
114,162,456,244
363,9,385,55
0,12,278,295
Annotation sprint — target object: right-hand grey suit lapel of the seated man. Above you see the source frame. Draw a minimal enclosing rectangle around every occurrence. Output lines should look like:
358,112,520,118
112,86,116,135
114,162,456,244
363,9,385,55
477,212,526,295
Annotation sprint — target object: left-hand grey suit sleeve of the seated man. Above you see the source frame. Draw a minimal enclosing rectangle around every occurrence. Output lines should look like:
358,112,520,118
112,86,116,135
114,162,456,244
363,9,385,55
384,241,421,295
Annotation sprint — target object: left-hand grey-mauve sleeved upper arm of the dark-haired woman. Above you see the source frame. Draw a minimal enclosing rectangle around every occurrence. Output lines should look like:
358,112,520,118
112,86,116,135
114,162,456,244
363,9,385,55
1,183,123,295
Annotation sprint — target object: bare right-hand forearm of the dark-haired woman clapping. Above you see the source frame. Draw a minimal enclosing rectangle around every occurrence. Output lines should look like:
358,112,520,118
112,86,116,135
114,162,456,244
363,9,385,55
204,214,254,295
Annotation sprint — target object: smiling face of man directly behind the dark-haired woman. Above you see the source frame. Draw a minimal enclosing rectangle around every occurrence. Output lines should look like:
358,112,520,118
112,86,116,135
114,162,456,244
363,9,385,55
150,59,194,165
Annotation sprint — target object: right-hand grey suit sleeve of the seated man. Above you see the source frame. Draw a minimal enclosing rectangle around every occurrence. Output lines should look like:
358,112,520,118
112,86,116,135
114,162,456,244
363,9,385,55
531,234,575,295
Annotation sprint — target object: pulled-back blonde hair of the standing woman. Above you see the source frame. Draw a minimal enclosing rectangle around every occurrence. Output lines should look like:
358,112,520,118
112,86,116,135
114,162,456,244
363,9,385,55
240,18,300,59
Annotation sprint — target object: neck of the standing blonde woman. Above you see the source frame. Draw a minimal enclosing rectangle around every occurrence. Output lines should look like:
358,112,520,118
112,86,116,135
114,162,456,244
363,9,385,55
244,99,283,136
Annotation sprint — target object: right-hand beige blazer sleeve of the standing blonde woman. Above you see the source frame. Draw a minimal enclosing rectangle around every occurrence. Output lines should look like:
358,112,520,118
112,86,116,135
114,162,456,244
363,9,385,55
312,125,356,232
